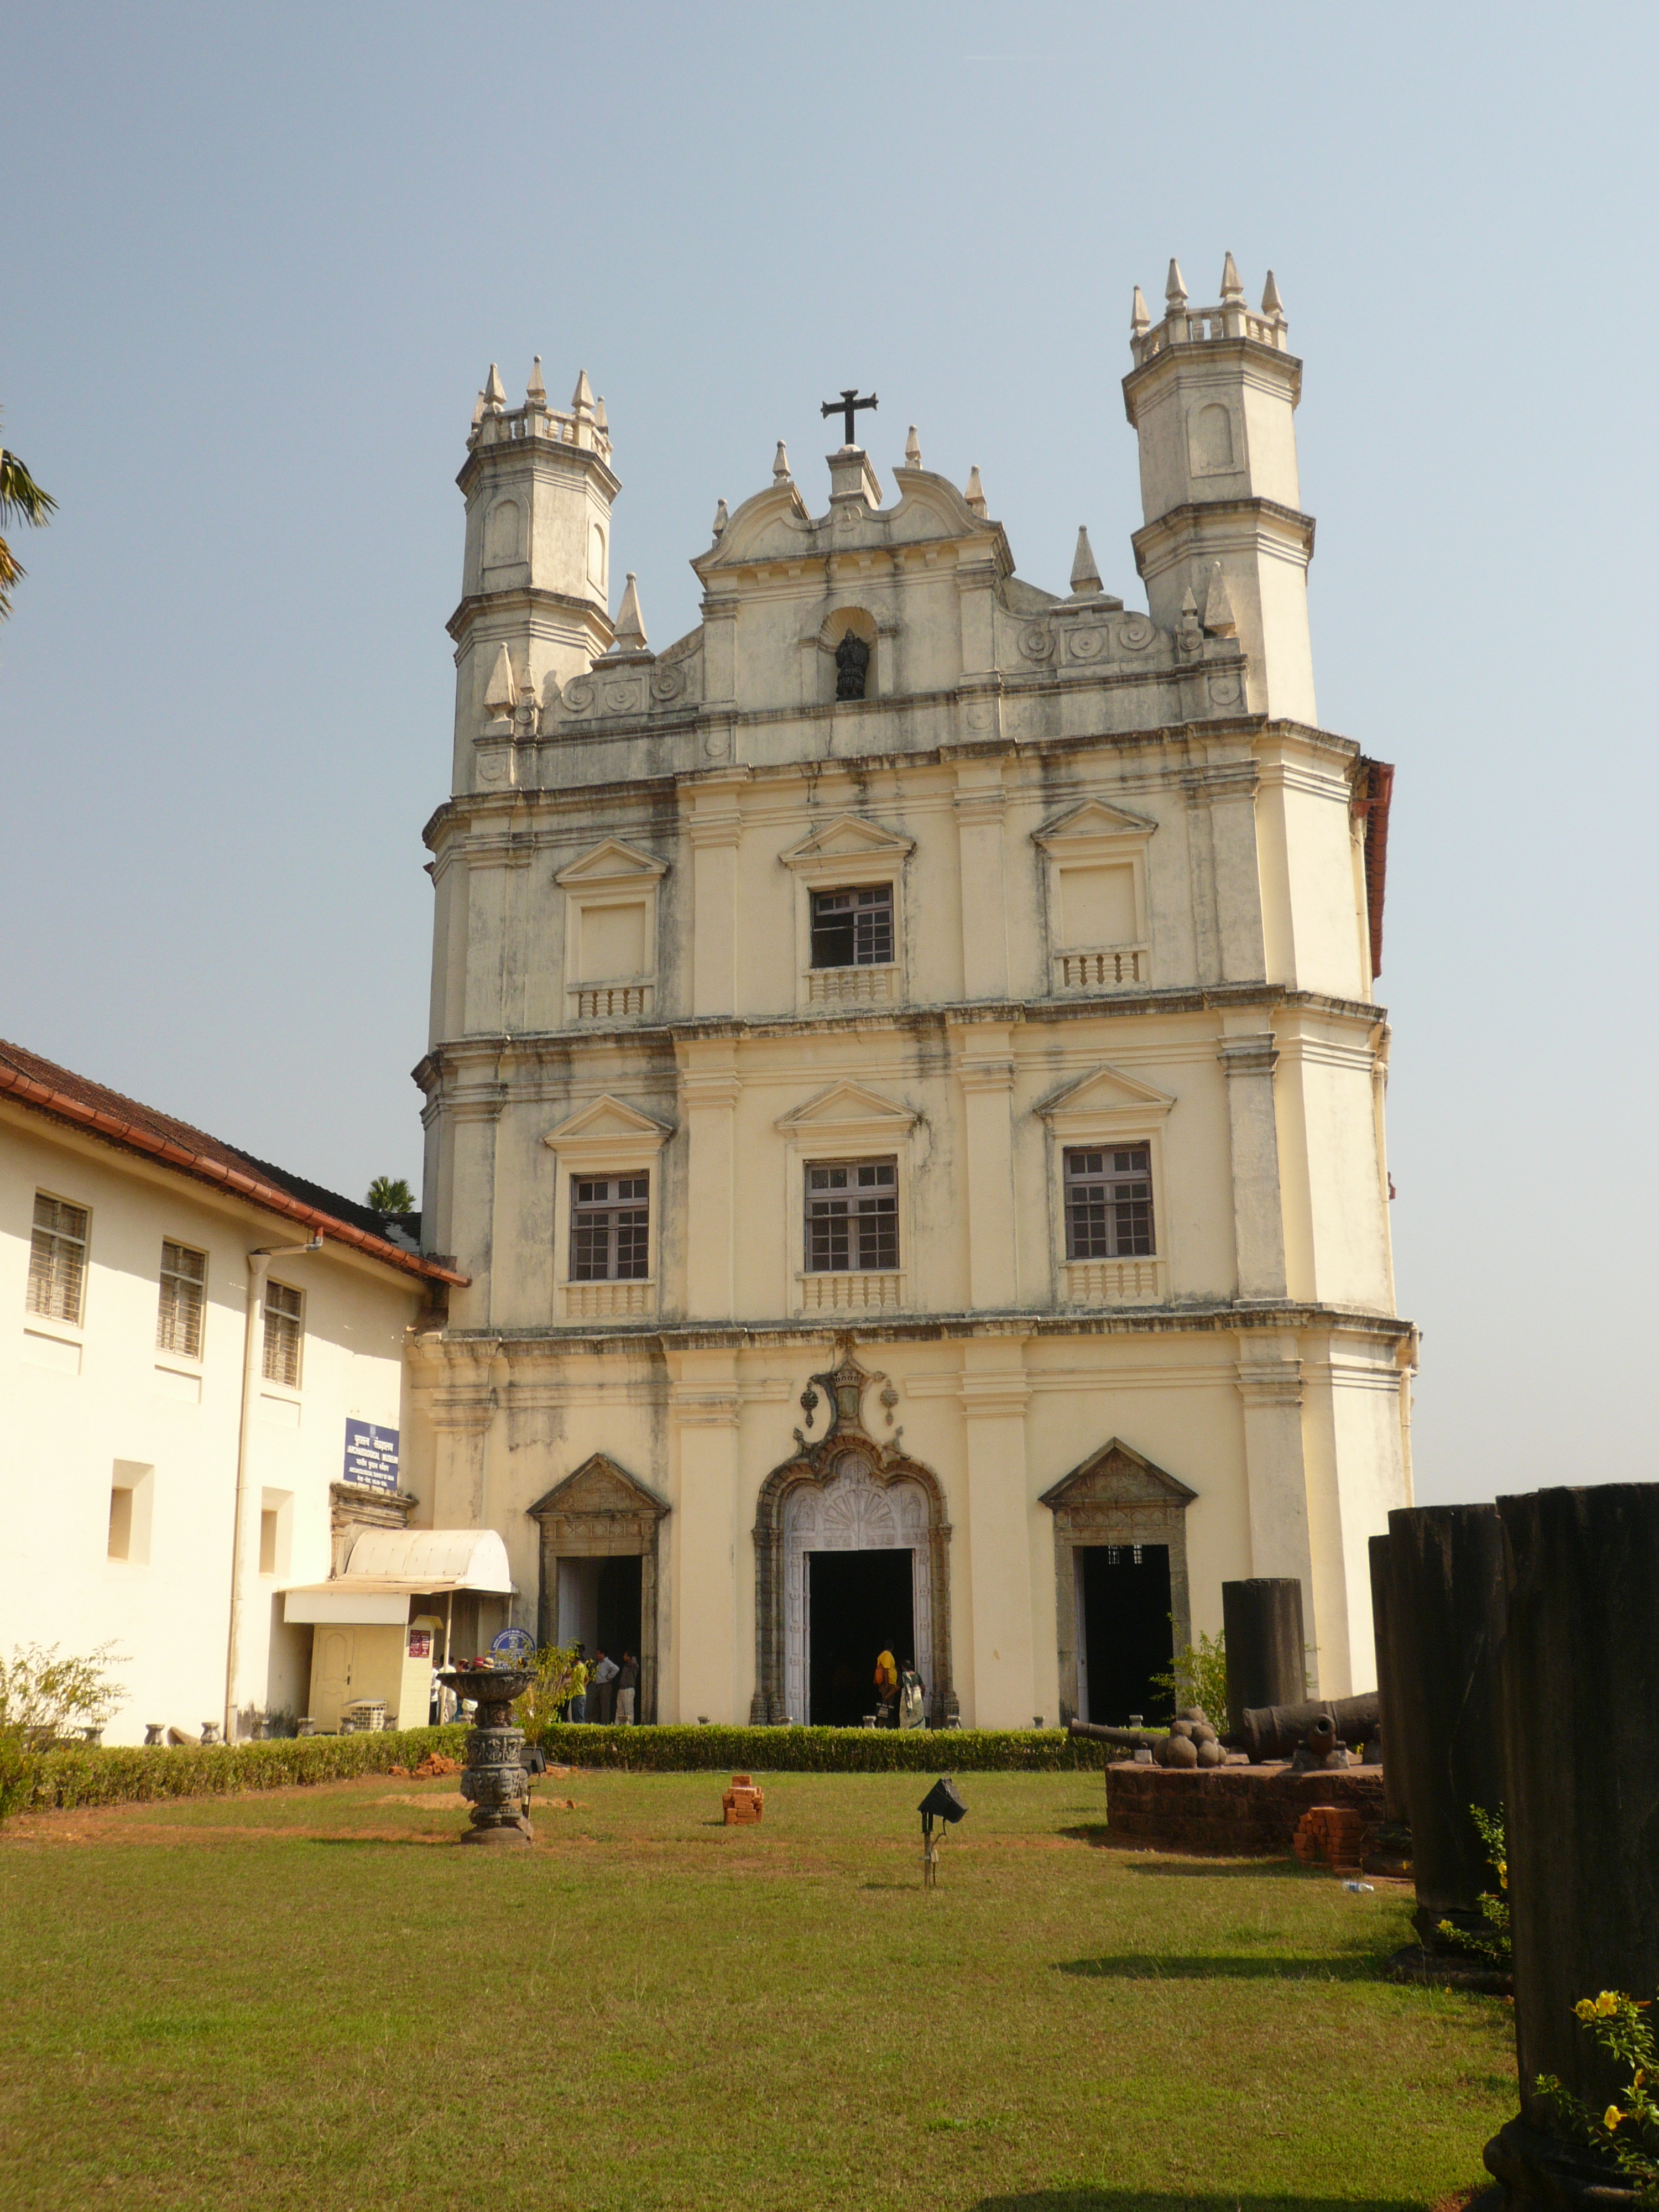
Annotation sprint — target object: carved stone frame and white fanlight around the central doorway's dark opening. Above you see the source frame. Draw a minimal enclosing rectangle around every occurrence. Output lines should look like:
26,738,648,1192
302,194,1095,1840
750,1338,958,1728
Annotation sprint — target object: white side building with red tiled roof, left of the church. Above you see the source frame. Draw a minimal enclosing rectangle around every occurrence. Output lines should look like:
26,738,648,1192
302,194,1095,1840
0,1044,480,1743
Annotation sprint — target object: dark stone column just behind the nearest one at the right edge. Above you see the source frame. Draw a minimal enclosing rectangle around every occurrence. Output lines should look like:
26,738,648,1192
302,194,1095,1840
1383,1506,1504,1958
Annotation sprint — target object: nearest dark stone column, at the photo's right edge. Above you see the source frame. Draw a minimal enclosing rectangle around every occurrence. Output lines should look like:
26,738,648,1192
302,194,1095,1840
1486,1482,1659,2205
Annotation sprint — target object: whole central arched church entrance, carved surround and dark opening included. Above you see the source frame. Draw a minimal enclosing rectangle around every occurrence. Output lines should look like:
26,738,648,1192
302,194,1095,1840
750,1338,958,1728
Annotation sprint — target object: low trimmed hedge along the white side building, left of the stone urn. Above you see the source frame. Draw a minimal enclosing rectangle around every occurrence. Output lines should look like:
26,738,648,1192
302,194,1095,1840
13,1723,467,1812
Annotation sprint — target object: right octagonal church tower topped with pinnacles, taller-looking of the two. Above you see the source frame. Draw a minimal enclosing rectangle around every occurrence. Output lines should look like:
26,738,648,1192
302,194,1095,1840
1124,254,1318,723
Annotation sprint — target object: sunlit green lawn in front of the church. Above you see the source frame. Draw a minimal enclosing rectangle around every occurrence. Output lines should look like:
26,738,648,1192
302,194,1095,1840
0,1774,1515,2212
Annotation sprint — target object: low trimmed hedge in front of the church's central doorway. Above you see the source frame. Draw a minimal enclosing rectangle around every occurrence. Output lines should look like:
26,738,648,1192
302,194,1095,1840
542,1721,1106,1774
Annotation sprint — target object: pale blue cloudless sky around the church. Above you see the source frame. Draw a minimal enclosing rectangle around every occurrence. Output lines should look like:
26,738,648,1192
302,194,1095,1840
0,0,1659,1502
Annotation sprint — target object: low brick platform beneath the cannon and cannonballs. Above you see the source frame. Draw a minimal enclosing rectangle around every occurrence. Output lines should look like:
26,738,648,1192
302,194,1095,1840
1106,1759,1385,1858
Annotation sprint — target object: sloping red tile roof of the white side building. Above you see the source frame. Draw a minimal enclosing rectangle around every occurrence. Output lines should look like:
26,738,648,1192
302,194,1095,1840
0,1040,471,1285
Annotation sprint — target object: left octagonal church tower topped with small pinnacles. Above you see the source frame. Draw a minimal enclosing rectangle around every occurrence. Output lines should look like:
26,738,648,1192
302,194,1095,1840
449,367,622,787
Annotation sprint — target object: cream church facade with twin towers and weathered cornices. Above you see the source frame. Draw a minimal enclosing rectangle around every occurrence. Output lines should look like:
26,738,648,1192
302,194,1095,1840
409,257,1416,1728
